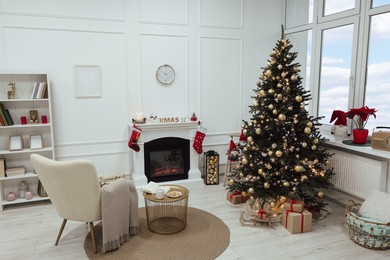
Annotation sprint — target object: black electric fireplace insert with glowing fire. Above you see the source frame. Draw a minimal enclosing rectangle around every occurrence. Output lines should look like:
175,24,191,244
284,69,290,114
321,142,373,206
144,137,190,182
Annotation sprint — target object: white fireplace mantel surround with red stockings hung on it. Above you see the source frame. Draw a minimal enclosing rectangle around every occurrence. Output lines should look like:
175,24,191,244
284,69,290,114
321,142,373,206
128,122,203,188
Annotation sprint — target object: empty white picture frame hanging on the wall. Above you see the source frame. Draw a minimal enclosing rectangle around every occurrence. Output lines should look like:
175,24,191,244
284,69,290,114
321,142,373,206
74,65,102,98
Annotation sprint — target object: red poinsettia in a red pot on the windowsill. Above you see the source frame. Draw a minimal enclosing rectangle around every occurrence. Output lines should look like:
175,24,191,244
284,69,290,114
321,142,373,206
345,106,377,144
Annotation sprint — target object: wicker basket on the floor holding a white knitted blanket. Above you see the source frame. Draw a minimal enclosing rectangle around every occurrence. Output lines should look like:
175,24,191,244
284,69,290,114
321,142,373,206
345,201,390,249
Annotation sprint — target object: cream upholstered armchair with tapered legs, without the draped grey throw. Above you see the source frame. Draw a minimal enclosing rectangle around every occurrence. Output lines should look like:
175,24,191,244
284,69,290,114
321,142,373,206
30,154,102,252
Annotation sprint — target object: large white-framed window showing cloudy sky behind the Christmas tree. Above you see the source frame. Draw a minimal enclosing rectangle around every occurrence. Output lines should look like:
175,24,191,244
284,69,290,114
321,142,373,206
285,0,390,134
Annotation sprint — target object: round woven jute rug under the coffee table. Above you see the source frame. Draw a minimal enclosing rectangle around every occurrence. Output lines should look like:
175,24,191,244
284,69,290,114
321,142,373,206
84,207,230,260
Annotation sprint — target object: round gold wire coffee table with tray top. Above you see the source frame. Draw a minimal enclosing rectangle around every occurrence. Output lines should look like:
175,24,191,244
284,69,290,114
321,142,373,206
143,185,189,234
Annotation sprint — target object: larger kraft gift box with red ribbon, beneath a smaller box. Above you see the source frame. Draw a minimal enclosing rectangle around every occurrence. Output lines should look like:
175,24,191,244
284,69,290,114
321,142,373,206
282,209,312,234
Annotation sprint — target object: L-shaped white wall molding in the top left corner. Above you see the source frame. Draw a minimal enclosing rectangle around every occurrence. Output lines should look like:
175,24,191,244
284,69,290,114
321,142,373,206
0,0,126,22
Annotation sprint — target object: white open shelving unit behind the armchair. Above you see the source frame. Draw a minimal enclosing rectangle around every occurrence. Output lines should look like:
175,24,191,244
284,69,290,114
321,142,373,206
0,73,55,211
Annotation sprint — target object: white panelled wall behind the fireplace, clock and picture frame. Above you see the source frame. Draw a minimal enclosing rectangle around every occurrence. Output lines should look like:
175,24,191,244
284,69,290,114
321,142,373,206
0,0,282,175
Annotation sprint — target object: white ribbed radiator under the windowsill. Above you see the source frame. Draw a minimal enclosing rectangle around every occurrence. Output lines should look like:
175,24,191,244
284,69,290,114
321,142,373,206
327,148,388,199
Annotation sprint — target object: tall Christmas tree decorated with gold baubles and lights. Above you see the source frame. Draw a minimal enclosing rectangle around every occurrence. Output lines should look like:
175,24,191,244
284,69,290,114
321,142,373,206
229,37,333,210
